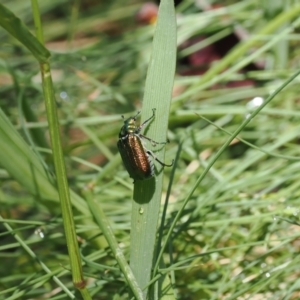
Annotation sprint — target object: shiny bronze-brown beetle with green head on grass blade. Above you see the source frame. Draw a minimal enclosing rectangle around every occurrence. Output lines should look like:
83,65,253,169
117,108,174,181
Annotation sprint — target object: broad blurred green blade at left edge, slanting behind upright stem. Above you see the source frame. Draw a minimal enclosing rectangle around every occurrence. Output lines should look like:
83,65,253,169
0,108,105,247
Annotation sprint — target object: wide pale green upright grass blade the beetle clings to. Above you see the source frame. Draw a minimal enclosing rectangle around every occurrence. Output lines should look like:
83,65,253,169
130,0,176,298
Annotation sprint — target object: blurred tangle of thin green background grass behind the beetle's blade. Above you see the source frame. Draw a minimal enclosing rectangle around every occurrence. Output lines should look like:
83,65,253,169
0,0,300,300
